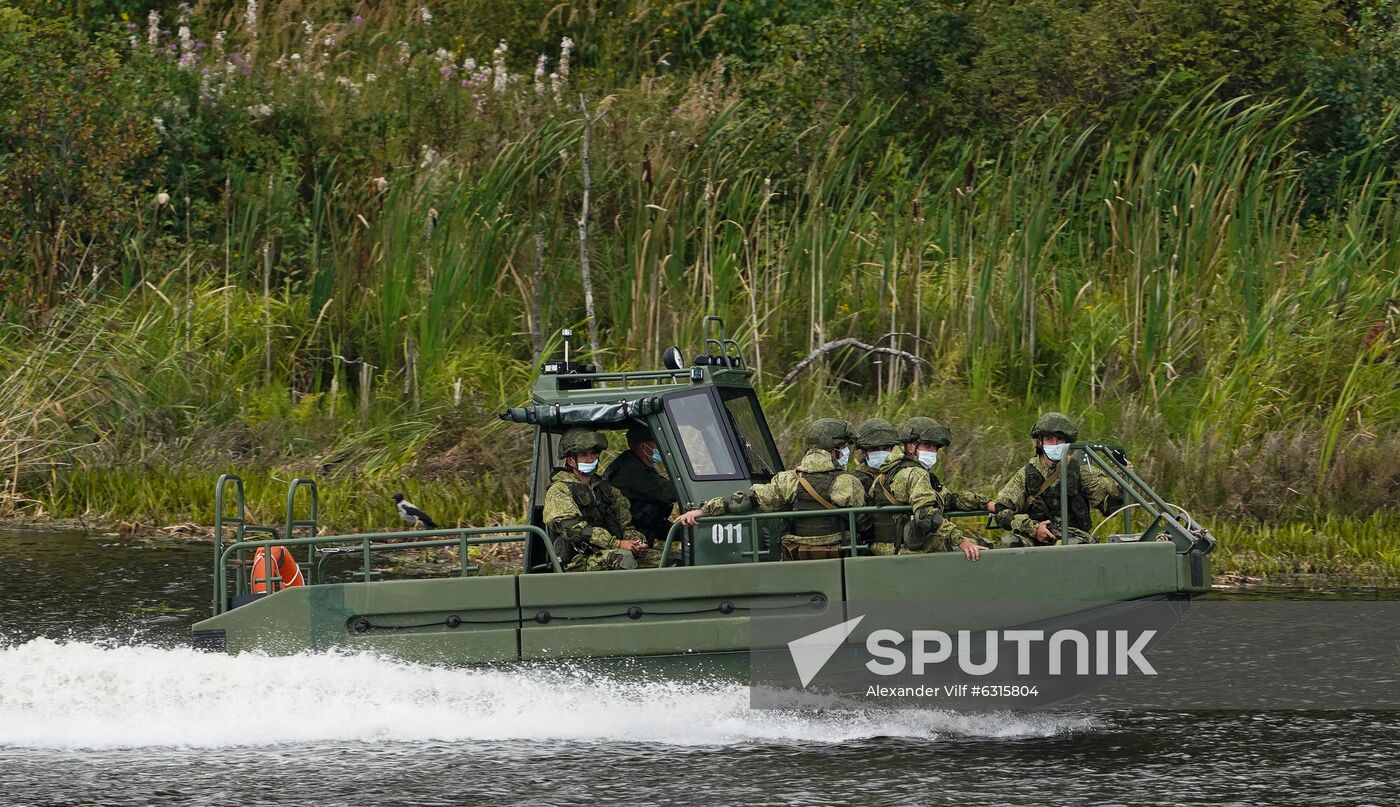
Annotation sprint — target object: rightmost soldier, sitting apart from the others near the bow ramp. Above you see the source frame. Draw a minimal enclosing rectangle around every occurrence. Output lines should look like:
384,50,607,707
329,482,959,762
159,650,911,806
987,412,1123,546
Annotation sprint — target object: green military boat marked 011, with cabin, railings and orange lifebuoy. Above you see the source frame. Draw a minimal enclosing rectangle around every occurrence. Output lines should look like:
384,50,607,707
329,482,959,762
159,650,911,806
193,317,1215,670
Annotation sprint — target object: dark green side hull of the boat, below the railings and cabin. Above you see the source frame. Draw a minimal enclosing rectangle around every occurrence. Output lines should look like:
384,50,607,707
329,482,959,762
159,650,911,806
195,541,1210,674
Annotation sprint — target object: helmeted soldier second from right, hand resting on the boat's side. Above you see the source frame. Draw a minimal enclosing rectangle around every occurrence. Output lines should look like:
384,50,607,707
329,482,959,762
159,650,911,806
869,418,983,560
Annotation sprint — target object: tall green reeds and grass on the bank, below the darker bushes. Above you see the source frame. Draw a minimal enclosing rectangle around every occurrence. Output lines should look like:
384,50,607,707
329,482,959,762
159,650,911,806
0,4,1400,574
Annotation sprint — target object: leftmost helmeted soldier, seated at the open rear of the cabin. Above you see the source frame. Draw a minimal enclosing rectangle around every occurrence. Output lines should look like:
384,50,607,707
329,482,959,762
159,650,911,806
545,427,650,572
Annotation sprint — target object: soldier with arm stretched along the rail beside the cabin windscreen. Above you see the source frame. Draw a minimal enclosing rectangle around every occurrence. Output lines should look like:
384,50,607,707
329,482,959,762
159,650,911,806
678,418,865,560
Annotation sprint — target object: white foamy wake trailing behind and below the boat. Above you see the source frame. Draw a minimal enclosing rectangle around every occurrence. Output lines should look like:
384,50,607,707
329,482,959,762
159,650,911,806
0,639,1091,750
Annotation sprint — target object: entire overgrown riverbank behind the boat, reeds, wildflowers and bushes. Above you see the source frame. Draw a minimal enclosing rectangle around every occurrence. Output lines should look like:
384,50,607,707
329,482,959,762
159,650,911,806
0,0,1400,570
